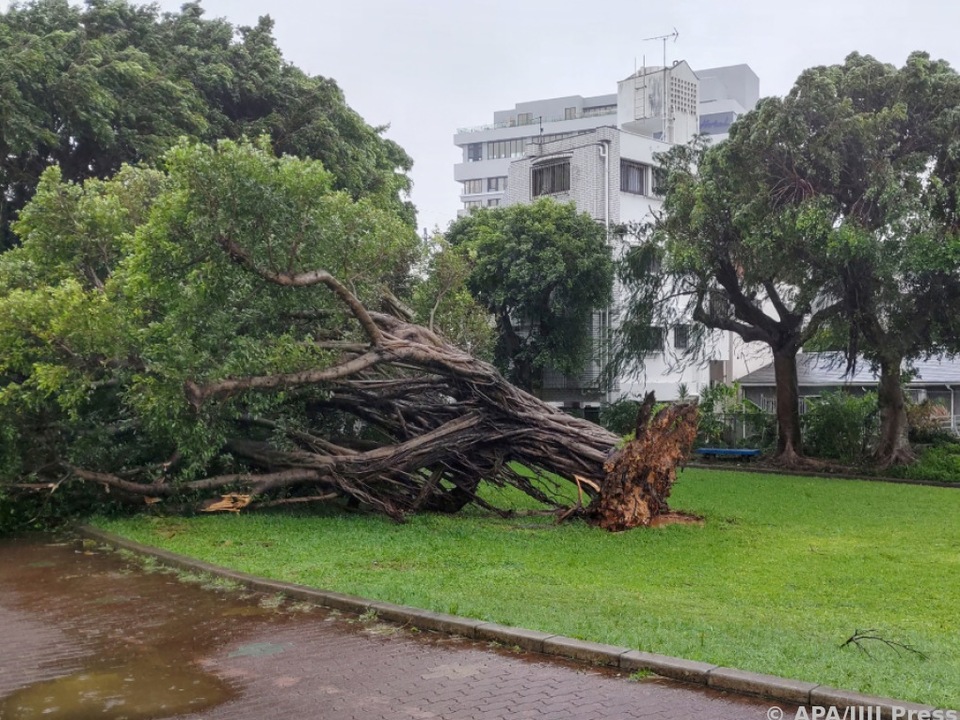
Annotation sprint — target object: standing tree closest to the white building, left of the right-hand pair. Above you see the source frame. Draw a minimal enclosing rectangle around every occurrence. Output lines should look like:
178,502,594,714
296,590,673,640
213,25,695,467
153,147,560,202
614,139,839,464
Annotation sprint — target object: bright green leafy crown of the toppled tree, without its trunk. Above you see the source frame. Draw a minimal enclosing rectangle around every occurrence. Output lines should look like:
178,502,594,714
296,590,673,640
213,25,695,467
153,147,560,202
0,135,419,506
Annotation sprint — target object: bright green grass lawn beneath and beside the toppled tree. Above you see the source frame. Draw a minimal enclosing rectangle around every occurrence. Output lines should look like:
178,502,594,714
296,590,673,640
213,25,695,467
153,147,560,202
96,469,960,708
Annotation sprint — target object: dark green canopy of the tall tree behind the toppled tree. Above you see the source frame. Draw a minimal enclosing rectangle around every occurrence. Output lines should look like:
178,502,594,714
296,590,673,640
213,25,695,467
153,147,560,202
0,0,413,246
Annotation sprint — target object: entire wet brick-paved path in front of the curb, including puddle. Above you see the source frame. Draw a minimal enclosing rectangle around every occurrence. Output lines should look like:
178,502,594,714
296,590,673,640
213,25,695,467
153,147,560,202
0,542,792,720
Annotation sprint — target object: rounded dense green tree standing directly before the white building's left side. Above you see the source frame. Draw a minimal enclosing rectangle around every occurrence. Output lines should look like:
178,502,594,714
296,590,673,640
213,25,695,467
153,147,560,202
447,198,614,393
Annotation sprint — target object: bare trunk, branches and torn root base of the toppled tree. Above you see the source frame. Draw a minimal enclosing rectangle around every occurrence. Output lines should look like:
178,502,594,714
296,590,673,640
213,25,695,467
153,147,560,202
63,278,696,530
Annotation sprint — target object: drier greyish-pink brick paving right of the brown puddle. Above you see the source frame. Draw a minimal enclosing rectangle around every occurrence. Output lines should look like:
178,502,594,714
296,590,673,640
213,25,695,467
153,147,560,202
182,623,769,720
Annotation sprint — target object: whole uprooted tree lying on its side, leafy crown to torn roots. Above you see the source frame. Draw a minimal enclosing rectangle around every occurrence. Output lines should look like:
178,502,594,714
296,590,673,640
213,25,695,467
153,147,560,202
0,143,695,529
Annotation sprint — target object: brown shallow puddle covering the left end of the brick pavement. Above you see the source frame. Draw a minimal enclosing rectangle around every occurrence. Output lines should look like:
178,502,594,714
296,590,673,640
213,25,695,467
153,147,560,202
0,540,294,720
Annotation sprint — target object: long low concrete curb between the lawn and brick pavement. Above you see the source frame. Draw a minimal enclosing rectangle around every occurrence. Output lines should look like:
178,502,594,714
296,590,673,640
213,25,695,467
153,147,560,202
77,525,942,720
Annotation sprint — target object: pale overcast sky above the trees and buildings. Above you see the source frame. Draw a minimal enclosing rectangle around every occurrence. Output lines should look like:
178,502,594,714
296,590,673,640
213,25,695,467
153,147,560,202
0,0,960,228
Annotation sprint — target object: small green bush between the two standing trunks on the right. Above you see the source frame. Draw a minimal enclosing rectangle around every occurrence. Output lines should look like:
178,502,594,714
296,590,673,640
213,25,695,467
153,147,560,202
803,391,878,464
